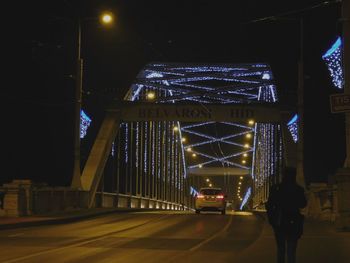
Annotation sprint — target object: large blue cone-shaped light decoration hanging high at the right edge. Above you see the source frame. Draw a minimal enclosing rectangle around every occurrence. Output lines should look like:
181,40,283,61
322,37,344,89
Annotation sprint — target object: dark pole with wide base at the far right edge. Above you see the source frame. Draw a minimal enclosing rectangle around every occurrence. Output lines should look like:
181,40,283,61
336,0,350,230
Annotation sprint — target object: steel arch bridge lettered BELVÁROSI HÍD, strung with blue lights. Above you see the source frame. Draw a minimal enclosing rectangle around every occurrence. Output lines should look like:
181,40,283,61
76,63,295,211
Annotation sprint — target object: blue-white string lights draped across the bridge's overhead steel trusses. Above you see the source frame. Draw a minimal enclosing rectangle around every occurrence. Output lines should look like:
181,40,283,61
120,63,281,209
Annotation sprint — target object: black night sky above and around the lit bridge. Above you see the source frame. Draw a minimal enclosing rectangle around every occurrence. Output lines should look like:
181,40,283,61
0,0,345,188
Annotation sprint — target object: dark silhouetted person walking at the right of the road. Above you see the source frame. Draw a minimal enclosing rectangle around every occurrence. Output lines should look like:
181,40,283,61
266,167,307,263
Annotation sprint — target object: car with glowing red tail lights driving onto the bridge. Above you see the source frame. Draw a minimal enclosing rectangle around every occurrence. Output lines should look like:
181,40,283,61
195,187,227,215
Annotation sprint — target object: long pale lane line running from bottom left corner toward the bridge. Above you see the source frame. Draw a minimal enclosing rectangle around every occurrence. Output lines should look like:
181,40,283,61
3,214,171,263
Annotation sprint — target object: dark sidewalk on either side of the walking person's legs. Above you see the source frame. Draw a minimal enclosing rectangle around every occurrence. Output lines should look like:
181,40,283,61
237,216,350,263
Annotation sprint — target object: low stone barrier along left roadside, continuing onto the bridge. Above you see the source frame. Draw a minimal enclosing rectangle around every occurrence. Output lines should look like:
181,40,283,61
0,180,190,216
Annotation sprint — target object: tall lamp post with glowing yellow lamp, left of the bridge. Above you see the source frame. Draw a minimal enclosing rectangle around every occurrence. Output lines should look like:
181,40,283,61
71,12,113,189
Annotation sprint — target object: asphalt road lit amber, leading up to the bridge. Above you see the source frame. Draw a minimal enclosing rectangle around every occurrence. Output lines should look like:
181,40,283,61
0,211,263,263
